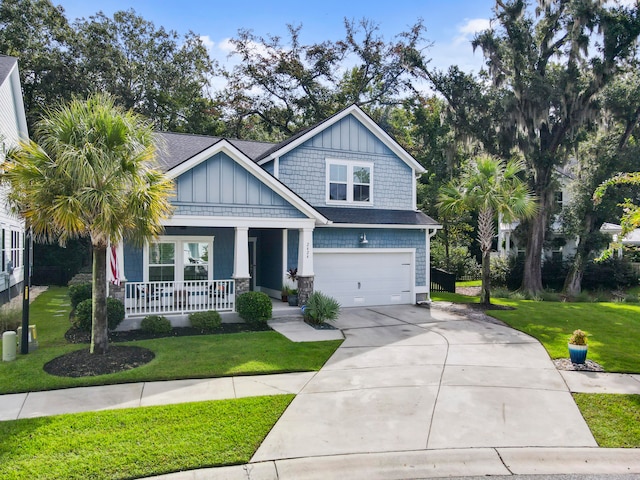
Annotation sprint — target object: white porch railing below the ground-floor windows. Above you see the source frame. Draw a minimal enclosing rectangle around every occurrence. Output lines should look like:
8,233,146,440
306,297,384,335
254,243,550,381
124,280,236,317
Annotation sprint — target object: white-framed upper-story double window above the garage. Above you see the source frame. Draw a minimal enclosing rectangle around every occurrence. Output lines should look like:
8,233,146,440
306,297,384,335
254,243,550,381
327,160,373,204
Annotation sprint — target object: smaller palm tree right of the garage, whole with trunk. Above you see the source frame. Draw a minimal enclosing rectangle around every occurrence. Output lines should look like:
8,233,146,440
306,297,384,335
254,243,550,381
438,156,537,305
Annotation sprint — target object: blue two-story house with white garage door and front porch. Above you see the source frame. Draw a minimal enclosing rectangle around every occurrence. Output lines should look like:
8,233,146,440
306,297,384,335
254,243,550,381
120,106,440,316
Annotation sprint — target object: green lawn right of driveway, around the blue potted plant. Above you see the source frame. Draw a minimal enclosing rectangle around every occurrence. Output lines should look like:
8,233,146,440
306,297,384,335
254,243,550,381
433,293,640,373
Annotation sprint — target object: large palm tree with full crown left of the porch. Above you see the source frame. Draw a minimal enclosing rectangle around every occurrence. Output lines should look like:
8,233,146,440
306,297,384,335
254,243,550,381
0,94,173,353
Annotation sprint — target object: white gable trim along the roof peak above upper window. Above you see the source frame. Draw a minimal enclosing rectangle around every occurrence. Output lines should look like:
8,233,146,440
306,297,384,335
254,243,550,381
257,105,426,173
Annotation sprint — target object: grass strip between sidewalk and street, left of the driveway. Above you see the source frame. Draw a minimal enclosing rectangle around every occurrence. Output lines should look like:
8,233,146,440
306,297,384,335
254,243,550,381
0,395,294,480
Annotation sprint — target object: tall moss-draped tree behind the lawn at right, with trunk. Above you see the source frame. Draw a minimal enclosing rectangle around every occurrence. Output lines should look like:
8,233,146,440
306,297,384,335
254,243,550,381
426,0,640,293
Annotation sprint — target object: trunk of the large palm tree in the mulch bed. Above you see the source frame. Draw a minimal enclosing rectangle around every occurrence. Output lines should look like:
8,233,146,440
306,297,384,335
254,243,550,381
91,245,109,354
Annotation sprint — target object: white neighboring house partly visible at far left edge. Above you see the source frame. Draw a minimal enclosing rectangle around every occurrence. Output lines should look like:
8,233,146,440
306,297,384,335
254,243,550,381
0,55,28,303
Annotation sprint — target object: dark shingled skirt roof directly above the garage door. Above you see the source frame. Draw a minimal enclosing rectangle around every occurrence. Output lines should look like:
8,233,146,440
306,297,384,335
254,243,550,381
315,207,439,227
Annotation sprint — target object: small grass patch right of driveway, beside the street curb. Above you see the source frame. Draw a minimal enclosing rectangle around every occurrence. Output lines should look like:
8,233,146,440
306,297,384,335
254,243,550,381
573,393,640,448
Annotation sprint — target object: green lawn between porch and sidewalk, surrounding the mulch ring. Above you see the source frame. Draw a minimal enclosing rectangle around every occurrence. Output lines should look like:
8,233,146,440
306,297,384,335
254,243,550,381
0,287,341,393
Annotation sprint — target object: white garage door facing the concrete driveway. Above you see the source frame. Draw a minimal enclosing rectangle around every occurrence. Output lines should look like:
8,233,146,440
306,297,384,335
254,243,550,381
313,250,413,307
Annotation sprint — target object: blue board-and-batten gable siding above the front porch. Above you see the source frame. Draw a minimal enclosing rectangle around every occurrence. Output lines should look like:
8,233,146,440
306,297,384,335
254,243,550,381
173,153,304,218
